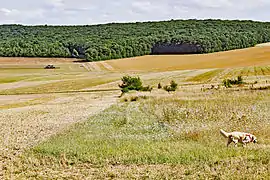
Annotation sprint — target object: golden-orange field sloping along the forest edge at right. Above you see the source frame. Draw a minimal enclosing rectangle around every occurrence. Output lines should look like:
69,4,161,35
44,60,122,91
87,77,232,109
104,46,270,71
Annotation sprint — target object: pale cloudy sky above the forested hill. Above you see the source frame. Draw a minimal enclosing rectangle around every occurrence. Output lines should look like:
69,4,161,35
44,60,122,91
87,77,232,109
0,0,270,25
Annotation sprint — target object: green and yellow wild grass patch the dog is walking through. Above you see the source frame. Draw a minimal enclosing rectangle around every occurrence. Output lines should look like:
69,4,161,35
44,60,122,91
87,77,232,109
13,91,270,179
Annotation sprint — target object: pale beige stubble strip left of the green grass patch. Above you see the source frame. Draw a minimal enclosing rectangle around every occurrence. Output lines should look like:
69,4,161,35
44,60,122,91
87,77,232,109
0,92,117,179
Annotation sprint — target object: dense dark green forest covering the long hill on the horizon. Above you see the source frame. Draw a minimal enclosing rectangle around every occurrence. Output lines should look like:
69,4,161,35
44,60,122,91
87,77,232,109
0,20,270,61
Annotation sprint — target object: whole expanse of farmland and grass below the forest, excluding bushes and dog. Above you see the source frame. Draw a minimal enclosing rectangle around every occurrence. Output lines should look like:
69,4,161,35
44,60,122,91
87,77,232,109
0,46,270,179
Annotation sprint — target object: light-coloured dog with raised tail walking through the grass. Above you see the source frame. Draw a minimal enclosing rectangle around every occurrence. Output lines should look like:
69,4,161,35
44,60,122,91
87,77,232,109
220,129,257,147
